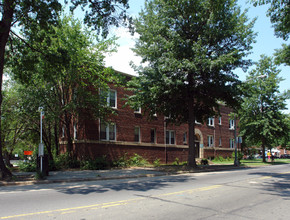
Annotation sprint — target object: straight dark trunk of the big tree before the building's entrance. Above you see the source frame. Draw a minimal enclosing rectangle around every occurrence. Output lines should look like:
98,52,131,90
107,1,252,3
188,74,196,167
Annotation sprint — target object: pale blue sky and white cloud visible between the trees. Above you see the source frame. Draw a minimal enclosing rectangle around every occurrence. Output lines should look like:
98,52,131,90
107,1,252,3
105,0,290,113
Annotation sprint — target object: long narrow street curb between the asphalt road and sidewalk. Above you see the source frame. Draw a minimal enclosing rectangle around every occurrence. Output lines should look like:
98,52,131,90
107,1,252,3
0,167,252,186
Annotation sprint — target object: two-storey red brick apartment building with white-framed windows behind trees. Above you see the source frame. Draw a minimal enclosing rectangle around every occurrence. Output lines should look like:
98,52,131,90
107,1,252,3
60,74,239,163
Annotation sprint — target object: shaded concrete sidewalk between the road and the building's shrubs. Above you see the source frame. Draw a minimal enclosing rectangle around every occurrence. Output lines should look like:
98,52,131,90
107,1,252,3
0,165,245,186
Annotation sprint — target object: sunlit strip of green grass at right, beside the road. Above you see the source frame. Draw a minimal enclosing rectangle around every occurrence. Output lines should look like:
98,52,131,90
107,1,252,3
212,159,290,167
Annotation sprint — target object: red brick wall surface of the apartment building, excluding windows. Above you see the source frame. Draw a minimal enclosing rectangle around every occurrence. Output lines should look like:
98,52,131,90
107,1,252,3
61,77,237,162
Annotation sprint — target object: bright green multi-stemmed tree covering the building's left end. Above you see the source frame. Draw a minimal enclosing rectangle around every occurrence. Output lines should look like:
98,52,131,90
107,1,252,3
11,17,118,160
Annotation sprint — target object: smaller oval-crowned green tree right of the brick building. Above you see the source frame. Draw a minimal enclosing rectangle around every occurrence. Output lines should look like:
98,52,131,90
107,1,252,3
239,56,289,162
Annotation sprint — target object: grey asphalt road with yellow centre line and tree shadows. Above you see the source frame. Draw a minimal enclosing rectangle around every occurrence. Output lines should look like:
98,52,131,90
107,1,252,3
0,165,290,220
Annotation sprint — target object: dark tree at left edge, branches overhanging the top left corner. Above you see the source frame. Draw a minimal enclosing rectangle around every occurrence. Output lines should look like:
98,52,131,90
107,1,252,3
0,0,129,178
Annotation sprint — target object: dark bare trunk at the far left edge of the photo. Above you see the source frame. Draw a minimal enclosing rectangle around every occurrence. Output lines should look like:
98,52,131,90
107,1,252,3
0,0,15,179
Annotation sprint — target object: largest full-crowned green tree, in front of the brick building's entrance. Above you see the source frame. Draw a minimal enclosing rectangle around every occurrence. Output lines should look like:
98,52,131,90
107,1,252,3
129,0,255,166
